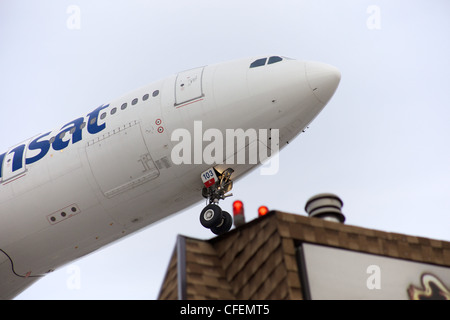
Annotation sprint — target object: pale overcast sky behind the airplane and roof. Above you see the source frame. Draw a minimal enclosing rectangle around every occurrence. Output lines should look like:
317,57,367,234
0,0,450,299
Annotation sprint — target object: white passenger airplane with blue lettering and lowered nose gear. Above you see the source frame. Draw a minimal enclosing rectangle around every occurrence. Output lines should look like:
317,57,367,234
0,55,341,299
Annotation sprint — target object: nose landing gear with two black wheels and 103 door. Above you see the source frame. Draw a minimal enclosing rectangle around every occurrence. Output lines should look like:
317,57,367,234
200,168,234,235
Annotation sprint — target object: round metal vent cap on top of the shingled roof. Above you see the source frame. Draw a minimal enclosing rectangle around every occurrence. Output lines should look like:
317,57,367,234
305,193,345,223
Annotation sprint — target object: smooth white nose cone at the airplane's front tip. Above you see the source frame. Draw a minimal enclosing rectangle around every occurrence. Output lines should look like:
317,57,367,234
305,62,341,104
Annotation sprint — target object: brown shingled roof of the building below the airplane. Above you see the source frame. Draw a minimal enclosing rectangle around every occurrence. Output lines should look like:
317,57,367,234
159,211,450,300
